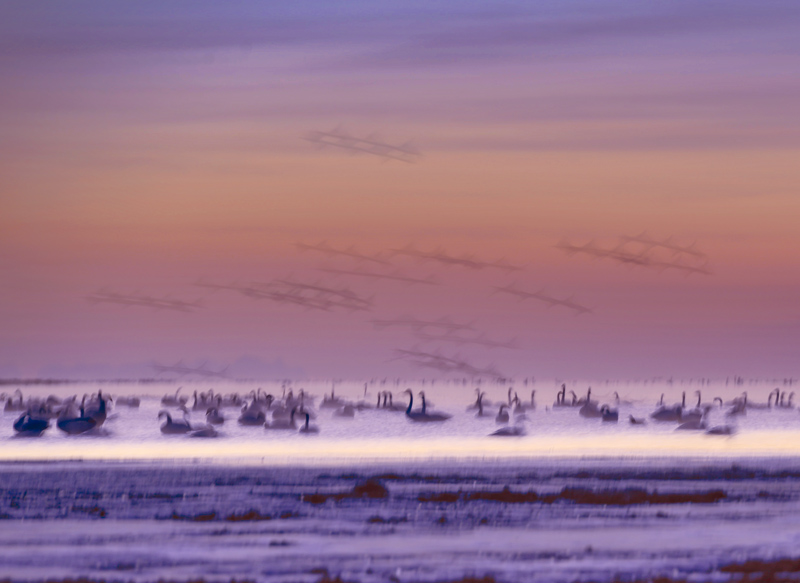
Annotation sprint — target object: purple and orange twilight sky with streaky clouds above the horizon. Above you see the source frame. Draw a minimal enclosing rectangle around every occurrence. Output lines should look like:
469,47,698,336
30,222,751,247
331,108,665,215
0,0,800,379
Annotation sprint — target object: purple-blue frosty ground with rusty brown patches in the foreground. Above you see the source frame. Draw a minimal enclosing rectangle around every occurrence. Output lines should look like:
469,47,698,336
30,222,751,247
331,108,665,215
0,459,800,582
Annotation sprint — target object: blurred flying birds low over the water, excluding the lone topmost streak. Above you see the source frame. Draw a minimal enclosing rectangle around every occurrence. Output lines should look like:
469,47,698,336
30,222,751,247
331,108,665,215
86,233,711,380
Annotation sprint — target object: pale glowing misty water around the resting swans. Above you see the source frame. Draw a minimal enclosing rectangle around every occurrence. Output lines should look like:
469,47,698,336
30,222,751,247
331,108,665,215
0,380,800,464
